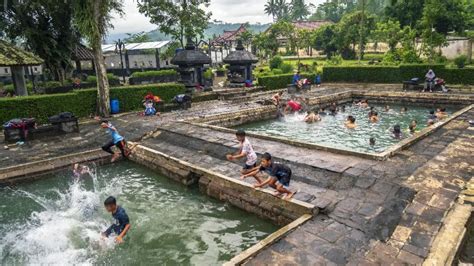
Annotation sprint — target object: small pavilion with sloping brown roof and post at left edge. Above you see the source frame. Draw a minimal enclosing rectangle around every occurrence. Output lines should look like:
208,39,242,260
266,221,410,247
0,40,43,96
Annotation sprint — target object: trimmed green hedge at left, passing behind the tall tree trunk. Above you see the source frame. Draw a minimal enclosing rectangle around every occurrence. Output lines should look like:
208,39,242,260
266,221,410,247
0,83,185,125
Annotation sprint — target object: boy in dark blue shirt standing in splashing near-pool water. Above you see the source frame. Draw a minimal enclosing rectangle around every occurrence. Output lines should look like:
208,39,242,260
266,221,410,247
102,196,130,244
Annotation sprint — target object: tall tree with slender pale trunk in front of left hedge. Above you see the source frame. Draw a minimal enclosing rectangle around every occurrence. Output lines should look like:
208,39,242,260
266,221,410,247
72,0,123,117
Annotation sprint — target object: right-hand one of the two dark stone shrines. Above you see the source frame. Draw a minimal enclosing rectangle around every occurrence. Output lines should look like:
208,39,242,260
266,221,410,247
224,40,258,86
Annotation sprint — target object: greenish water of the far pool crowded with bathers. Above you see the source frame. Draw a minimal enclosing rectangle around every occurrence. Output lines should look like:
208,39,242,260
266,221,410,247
239,103,452,153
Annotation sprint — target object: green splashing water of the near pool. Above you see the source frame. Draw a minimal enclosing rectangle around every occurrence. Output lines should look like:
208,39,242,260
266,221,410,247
0,162,278,265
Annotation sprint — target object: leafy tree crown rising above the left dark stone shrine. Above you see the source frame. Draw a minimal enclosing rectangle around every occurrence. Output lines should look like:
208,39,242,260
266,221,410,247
137,0,211,47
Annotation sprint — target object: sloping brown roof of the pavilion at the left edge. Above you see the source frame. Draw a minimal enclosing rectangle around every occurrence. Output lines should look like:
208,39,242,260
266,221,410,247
0,40,43,66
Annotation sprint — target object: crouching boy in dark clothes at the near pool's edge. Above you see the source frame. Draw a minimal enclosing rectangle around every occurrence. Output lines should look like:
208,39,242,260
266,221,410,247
242,152,296,199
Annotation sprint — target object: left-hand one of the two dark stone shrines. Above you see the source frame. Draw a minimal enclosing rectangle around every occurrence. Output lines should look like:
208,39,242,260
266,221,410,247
171,39,212,87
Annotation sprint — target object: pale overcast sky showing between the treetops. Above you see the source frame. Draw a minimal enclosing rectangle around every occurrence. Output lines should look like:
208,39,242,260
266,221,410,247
110,0,324,34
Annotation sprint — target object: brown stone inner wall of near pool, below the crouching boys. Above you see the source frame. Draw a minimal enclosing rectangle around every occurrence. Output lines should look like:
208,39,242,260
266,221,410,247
130,145,318,225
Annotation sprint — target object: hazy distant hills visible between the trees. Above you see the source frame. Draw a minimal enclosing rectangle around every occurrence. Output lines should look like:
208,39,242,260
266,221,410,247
106,22,270,43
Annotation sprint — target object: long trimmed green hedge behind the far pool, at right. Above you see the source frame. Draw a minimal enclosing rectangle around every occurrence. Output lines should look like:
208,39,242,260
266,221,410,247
323,64,474,85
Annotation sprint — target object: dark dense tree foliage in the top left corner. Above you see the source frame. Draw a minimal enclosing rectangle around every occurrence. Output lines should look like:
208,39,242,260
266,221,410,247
0,0,80,83
